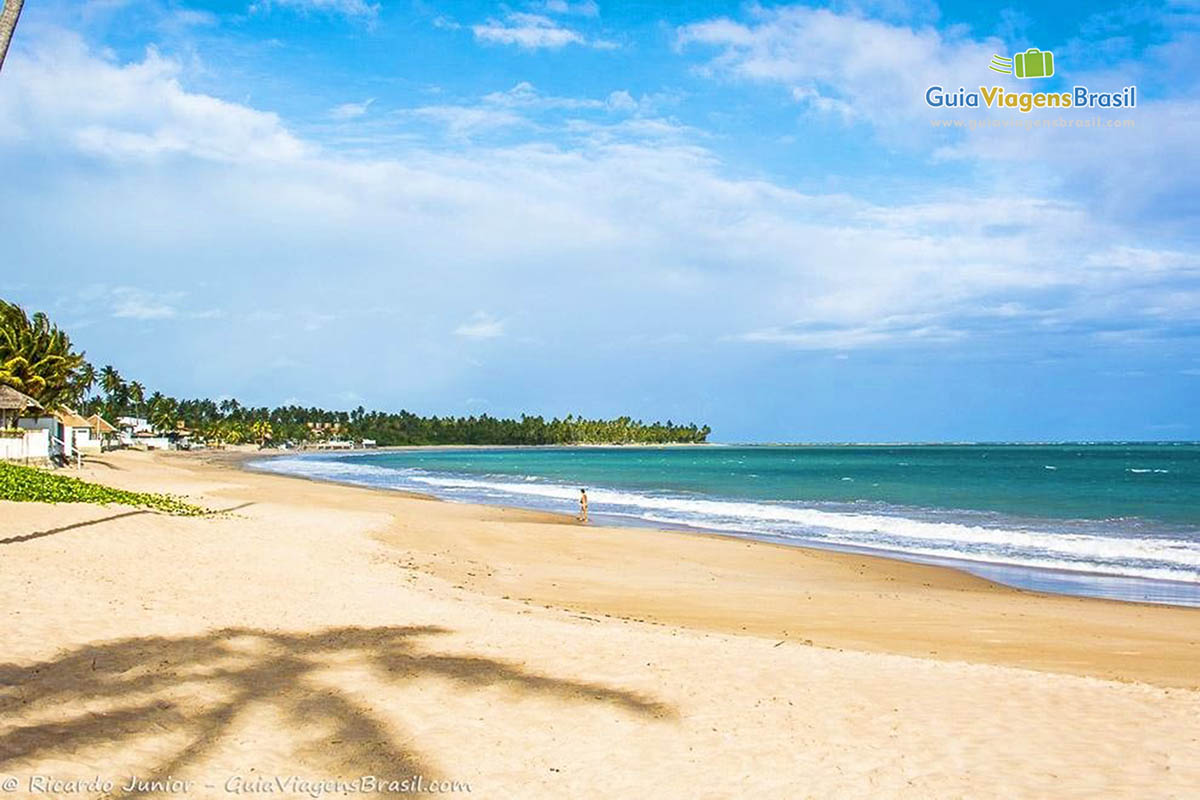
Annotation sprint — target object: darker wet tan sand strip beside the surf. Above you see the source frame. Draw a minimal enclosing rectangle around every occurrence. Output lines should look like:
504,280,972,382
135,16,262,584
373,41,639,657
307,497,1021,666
216,456,1200,688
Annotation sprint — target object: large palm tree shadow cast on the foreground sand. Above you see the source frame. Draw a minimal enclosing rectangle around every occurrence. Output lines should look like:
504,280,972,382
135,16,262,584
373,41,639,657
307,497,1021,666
0,626,674,796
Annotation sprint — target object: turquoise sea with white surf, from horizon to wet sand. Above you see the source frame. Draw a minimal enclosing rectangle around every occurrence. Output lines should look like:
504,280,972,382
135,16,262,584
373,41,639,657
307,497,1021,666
254,443,1200,606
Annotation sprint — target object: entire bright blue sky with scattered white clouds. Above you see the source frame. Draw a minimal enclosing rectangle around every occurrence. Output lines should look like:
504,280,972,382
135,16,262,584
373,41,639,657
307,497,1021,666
0,0,1200,441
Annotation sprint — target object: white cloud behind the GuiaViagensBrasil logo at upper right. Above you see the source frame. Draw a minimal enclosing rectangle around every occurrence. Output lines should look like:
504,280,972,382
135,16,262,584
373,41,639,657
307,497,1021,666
677,6,1200,233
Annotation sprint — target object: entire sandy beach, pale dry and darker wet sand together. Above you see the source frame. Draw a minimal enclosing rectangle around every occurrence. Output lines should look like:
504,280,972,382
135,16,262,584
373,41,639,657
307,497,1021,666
0,452,1200,798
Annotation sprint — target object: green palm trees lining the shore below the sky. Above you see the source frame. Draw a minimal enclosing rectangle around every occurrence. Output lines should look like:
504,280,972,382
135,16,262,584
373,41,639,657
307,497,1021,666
0,300,710,446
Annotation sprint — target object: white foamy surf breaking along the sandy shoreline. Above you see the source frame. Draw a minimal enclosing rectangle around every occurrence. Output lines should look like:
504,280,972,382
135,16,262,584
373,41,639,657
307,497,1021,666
254,458,1200,583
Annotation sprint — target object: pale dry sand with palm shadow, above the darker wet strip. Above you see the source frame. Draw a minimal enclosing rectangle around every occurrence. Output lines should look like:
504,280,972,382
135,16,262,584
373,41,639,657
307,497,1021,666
0,455,1200,799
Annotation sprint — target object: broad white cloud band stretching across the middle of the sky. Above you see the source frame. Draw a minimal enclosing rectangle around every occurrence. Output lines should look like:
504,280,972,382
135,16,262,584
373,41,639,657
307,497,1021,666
0,32,1200,357
